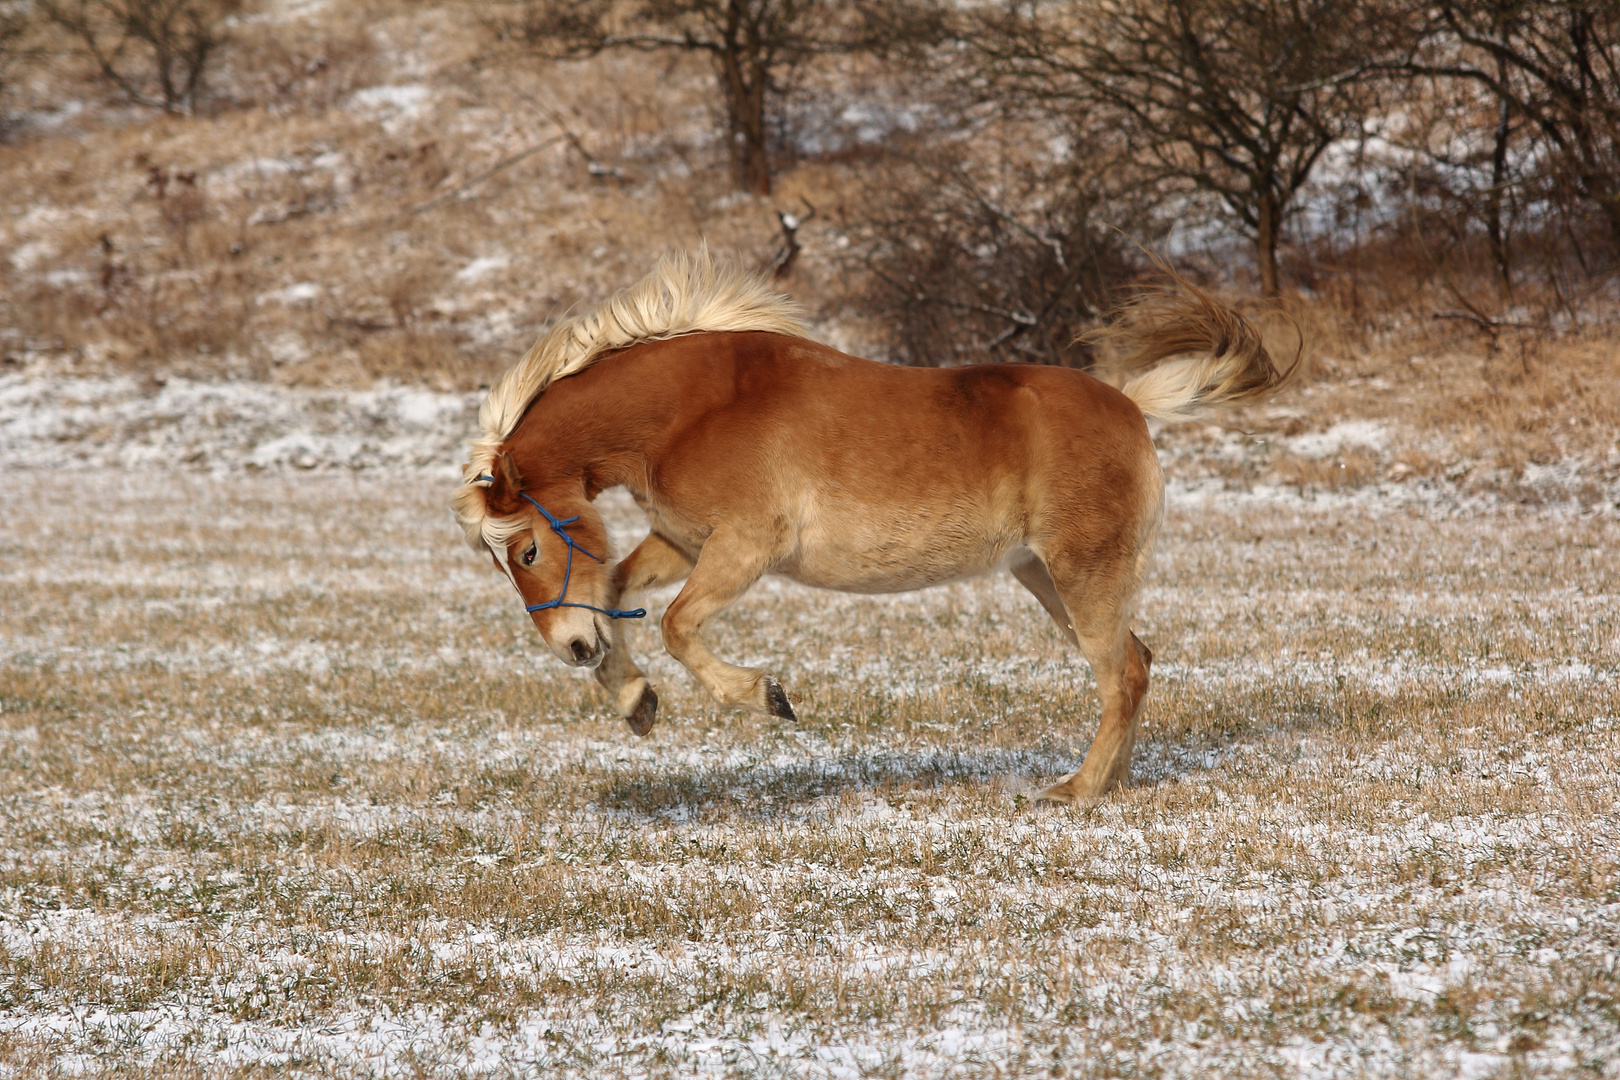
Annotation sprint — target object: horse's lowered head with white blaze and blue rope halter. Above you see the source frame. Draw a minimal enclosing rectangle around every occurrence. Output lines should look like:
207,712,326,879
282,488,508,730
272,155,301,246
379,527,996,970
475,453,624,667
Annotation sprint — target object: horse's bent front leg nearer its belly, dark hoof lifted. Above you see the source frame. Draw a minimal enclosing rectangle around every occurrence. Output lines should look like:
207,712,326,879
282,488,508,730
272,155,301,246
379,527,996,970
663,526,799,721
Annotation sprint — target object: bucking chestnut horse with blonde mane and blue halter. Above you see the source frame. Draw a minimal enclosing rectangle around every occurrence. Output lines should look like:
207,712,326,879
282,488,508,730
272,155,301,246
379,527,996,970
452,249,1298,803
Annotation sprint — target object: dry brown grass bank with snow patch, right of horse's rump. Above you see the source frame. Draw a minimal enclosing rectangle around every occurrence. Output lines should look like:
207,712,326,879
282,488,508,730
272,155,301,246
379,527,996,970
1158,301,1620,508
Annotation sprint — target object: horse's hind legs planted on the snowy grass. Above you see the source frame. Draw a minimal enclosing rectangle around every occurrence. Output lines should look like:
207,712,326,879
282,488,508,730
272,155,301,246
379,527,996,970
1013,559,1153,803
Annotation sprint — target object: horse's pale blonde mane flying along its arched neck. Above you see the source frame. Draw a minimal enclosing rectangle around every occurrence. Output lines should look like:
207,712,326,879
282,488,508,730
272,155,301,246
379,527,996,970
450,246,805,551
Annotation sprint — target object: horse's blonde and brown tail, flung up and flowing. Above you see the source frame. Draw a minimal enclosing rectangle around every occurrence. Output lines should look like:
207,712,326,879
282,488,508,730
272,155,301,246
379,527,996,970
1082,259,1304,419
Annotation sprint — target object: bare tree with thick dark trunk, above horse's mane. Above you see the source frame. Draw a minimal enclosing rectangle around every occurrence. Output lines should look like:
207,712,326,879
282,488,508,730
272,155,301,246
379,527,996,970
505,0,880,194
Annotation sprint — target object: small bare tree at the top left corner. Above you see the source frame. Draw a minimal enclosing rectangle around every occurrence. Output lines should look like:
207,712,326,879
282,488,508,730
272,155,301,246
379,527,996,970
39,0,241,112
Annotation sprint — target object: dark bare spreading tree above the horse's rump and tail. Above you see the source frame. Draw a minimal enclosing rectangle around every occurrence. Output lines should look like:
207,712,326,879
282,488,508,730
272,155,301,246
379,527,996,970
962,0,1387,296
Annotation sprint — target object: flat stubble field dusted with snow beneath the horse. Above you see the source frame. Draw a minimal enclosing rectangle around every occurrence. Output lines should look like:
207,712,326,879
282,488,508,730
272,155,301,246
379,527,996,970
0,376,1620,1078
